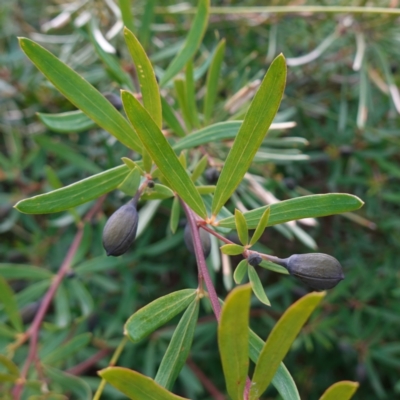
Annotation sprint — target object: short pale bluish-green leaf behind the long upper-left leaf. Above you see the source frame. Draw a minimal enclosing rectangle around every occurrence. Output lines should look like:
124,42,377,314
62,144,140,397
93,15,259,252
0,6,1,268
36,110,97,133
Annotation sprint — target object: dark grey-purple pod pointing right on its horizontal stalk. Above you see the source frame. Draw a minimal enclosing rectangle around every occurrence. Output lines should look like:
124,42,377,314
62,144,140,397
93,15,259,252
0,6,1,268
284,253,344,290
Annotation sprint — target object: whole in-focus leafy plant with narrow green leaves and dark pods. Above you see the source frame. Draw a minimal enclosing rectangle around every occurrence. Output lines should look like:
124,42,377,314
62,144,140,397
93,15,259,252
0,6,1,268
9,0,363,400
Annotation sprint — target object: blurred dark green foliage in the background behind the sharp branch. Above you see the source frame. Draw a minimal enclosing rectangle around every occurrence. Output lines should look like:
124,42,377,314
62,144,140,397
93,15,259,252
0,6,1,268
0,0,400,400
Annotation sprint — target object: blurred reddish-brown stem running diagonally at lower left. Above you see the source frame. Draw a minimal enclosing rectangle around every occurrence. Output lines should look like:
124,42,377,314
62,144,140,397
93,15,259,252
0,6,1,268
13,196,105,400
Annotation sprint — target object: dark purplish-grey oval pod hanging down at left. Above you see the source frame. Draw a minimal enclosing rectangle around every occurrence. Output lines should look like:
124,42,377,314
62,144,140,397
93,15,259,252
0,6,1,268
103,202,139,256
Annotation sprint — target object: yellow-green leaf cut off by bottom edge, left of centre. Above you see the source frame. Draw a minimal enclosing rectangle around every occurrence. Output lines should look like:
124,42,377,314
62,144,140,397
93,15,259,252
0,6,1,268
98,367,188,400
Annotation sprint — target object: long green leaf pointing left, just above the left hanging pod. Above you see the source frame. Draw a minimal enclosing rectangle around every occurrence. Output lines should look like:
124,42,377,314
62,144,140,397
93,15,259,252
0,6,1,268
14,165,129,214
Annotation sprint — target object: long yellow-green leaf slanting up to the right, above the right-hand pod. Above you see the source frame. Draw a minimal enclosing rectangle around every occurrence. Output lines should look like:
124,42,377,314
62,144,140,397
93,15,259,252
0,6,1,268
212,54,286,215
